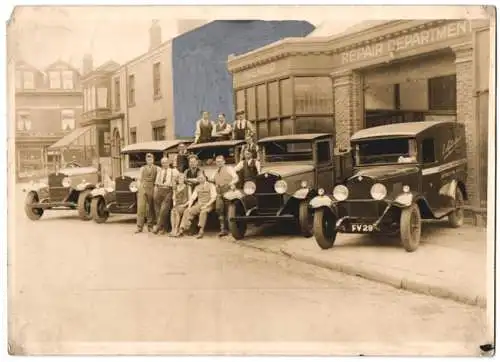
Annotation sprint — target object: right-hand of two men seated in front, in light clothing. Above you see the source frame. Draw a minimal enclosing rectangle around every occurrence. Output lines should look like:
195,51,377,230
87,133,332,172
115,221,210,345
177,173,217,239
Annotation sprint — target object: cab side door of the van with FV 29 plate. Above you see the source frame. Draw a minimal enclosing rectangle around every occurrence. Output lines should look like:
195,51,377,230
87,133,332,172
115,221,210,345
420,136,441,210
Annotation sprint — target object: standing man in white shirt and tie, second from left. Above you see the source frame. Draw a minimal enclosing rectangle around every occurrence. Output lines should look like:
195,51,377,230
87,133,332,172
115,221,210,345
153,157,179,235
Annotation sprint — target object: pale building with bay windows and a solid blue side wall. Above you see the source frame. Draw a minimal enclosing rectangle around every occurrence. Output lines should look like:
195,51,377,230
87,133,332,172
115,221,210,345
69,20,313,177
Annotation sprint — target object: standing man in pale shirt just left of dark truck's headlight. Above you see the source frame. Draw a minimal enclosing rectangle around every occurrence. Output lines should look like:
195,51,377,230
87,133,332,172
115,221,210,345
212,155,238,236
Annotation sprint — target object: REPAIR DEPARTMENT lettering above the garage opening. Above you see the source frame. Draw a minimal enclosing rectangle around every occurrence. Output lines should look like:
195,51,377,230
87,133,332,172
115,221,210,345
341,20,472,65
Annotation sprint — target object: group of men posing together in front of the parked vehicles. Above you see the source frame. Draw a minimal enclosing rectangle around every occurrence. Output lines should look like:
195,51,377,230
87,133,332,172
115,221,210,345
136,123,261,238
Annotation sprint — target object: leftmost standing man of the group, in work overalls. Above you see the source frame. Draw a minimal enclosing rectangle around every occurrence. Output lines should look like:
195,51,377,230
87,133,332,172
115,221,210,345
135,153,159,234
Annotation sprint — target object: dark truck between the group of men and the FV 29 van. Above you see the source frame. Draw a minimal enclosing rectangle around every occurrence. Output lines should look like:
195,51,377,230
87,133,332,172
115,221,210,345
224,133,351,239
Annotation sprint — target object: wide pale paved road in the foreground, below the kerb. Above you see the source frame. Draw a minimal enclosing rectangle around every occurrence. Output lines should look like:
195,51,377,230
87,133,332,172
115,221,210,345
10,188,485,354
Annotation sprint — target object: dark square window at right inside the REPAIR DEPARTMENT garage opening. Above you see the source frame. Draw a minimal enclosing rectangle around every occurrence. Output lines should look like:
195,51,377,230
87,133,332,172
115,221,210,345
429,74,457,111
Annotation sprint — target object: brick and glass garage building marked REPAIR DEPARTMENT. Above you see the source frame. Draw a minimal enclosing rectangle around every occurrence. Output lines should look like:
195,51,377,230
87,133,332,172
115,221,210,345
228,19,490,218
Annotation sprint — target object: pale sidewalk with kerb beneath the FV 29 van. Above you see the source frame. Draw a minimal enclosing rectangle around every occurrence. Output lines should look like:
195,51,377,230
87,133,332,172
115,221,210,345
241,222,487,308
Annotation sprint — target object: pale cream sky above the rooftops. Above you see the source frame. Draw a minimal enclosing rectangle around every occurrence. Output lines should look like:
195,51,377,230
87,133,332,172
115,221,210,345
9,5,484,69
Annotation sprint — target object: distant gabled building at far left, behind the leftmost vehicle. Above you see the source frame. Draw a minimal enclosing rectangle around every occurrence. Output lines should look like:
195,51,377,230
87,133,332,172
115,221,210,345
14,61,83,178
